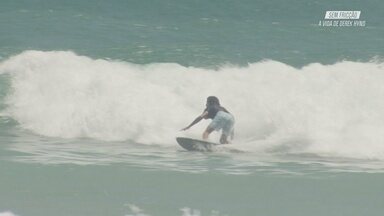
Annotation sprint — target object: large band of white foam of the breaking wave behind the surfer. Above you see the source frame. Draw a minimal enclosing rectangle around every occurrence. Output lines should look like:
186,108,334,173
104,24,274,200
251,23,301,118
0,51,384,158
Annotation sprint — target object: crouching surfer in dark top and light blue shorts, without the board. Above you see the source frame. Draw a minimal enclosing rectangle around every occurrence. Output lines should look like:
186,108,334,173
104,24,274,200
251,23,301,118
182,96,235,144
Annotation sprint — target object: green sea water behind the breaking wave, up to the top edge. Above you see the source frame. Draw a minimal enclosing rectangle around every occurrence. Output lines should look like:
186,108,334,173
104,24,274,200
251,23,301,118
0,0,383,66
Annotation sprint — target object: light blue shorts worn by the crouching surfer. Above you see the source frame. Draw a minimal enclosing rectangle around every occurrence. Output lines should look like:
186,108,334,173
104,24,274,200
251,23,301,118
208,111,235,136
